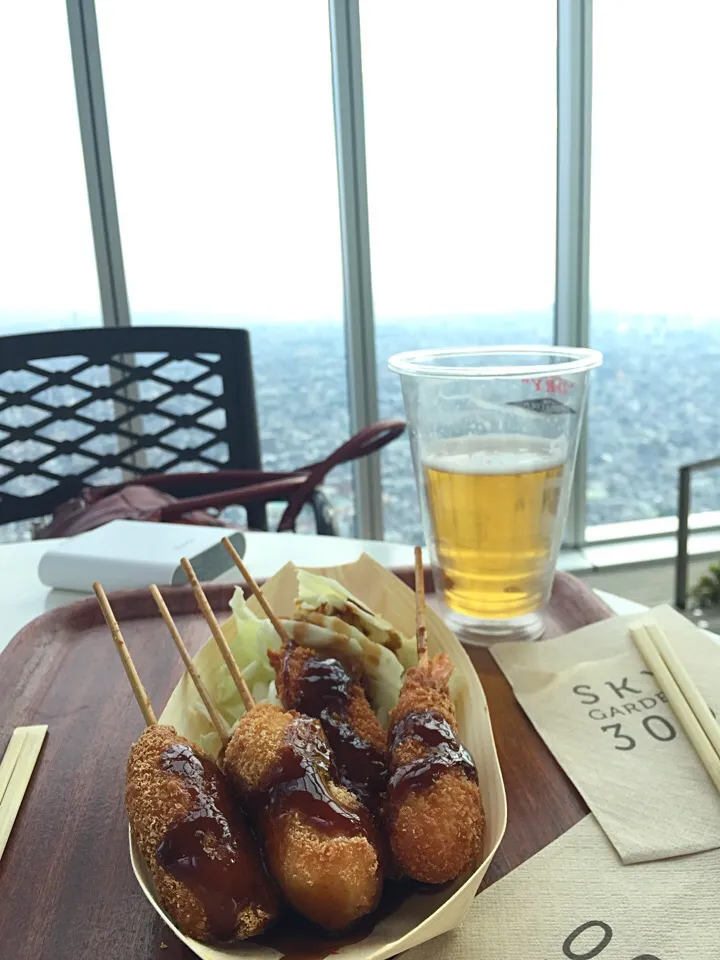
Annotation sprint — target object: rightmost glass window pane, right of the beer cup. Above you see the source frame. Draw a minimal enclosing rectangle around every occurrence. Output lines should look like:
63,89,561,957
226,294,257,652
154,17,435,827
587,0,720,524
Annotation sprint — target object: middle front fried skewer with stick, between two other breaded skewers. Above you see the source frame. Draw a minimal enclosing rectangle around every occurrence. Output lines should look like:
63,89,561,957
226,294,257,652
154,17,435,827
182,560,383,930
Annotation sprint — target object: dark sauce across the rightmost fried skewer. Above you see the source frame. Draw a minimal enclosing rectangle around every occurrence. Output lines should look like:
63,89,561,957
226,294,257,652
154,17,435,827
388,710,478,810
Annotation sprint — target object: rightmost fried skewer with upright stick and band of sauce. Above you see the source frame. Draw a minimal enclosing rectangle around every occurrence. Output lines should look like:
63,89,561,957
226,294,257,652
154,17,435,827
385,547,484,883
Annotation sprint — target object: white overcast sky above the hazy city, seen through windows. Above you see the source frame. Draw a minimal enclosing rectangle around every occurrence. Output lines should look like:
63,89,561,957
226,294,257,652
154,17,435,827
0,0,720,320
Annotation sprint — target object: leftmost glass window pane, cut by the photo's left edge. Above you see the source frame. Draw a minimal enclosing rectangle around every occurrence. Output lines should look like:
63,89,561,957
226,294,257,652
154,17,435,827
0,0,101,335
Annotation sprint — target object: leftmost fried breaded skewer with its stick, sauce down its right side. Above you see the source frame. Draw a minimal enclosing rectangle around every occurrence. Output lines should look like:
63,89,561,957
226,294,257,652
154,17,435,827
93,583,278,942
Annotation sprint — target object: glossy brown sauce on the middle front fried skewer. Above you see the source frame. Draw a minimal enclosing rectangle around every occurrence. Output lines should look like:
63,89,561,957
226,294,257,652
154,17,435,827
258,717,373,836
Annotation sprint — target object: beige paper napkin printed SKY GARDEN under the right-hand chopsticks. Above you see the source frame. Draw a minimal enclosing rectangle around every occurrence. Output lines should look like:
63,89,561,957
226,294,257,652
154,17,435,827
492,606,720,864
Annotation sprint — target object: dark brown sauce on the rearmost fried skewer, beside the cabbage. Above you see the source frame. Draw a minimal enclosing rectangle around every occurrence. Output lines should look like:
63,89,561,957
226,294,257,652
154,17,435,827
283,647,387,812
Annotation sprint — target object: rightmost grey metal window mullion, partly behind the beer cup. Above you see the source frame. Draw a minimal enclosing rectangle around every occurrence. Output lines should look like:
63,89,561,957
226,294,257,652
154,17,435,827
554,0,592,546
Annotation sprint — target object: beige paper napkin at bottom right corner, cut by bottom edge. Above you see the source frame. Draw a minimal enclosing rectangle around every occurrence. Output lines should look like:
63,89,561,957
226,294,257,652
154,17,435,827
404,815,720,960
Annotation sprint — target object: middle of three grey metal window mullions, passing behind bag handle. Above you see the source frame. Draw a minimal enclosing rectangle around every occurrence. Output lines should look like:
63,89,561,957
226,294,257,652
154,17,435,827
329,0,383,540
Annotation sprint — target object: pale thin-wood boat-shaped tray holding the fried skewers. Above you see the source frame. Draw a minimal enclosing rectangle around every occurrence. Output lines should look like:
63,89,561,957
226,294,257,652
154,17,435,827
130,555,507,960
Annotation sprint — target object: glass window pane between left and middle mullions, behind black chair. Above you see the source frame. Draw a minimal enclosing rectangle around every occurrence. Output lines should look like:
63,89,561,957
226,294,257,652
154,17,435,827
97,0,353,532
